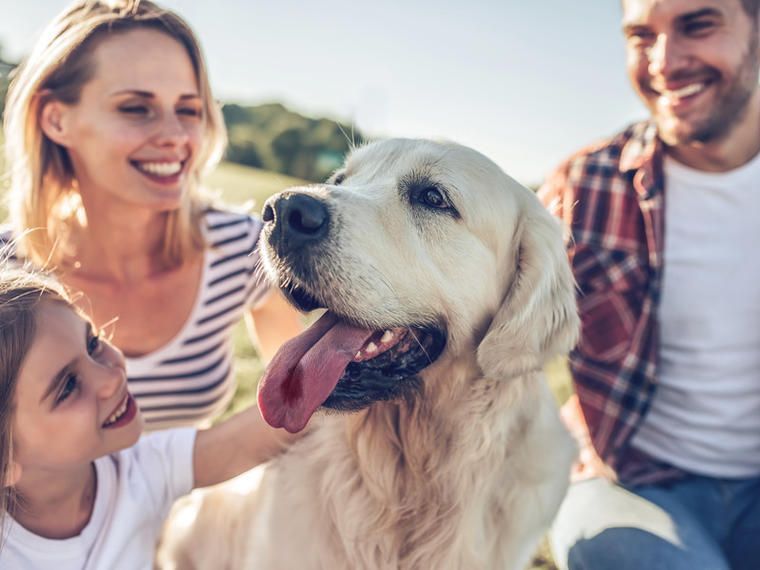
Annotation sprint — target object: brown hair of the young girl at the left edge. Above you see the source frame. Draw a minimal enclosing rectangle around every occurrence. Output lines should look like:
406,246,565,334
0,262,74,528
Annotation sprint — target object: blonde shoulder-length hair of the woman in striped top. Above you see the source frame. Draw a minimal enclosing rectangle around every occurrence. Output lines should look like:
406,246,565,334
4,0,227,267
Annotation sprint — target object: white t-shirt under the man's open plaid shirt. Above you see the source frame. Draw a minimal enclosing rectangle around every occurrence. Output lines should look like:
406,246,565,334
632,150,760,478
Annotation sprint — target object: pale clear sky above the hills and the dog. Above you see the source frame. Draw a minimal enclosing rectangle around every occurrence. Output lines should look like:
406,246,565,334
0,0,646,184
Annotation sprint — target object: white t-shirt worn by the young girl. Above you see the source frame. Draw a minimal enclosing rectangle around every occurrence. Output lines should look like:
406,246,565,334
0,428,196,570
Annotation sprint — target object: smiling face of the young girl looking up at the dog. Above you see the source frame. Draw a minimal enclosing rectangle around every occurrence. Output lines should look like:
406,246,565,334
13,300,142,474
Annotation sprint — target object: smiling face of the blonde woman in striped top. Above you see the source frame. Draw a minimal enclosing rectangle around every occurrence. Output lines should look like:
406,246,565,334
49,29,204,212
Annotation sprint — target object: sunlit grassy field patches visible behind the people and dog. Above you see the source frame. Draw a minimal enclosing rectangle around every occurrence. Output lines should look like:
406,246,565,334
0,153,570,570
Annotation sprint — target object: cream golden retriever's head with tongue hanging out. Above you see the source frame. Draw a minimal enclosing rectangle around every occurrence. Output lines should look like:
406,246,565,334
259,139,578,431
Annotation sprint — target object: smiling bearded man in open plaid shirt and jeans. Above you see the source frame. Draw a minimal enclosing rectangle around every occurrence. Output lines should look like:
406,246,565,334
540,0,760,570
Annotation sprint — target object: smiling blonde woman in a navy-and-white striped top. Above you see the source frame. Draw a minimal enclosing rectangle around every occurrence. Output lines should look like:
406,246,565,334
3,0,301,429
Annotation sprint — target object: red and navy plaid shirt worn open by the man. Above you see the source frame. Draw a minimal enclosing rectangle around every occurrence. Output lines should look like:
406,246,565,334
539,122,684,485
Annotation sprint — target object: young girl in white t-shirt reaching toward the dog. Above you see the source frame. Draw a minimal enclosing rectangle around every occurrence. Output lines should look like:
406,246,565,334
0,266,300,570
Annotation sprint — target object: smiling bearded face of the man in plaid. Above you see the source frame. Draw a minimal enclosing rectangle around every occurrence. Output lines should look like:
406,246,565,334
623,0,760,146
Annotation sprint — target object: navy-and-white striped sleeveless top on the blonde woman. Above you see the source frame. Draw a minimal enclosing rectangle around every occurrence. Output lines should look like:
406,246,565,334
0,210,269,430
